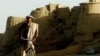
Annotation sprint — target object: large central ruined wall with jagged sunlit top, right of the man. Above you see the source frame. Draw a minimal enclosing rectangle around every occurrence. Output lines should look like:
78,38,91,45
31,4,72,52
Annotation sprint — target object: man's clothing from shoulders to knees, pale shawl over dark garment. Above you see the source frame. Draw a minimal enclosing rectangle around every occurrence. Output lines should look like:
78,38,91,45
21,23,38,49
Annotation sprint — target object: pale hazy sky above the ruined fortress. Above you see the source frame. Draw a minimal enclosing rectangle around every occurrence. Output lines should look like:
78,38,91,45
0,0,89,33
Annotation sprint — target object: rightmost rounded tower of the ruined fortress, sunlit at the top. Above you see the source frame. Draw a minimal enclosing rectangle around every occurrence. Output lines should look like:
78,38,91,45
74,0,100,52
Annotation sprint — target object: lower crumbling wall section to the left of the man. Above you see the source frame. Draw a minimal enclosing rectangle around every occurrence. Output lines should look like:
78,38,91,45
0,16,24,56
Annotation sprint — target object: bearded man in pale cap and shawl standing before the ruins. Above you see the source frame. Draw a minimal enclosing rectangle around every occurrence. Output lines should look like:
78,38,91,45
20,16,38,56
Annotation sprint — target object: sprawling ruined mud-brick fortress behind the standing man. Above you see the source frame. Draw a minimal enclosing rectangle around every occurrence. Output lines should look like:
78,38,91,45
0,0,100,56
